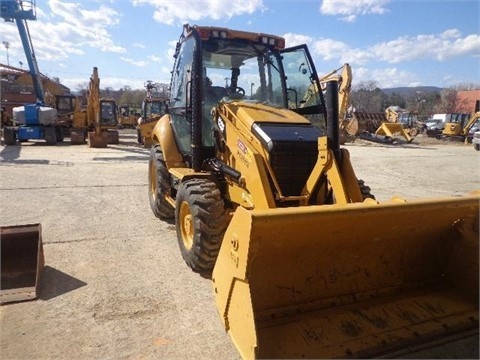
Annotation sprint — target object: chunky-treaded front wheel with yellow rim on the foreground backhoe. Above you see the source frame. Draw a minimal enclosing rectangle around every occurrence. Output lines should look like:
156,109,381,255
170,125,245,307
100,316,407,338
175,179,228,271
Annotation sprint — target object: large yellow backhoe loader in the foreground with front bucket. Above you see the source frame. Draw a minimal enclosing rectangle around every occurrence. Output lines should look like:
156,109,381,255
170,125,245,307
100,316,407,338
148,24,480,359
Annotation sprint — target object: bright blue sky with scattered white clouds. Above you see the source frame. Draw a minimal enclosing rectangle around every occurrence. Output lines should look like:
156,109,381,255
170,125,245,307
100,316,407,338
0,0,480,91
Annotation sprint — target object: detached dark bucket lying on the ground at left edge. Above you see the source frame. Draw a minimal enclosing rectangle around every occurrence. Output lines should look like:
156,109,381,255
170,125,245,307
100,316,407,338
0,224,45,303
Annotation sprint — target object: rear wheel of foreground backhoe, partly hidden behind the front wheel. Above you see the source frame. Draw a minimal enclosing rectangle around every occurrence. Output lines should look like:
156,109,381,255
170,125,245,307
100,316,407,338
148,145,175,219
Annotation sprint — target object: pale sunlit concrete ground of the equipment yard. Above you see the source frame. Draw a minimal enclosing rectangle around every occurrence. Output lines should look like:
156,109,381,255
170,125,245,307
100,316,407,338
0,131,480,360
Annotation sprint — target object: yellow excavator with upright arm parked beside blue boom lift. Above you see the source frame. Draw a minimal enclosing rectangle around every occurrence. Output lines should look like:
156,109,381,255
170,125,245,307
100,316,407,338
70,67,119,148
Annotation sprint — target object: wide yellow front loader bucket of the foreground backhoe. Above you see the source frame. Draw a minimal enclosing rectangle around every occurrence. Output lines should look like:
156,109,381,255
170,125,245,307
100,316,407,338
212,196,480,359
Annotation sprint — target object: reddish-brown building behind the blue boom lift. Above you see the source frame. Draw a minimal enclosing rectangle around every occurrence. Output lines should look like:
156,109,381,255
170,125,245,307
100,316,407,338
0,64,70,116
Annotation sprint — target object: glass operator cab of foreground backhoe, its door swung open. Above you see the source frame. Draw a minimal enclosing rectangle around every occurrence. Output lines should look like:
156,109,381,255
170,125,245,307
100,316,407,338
169,25,326,169
